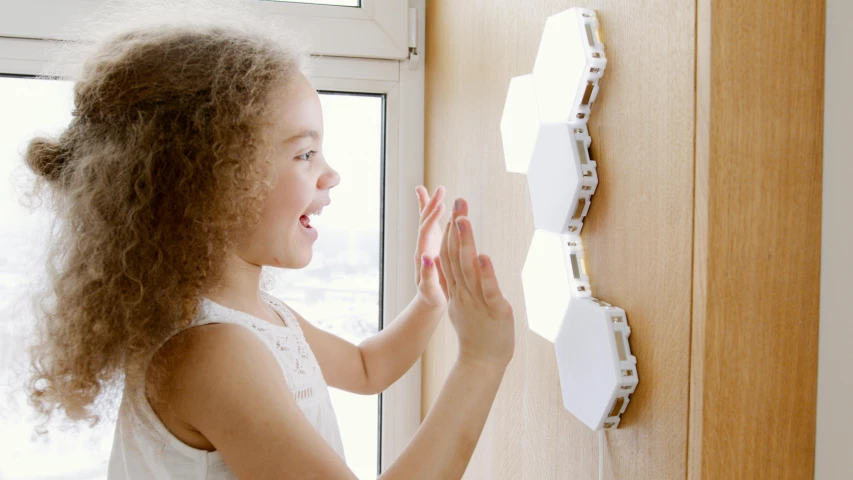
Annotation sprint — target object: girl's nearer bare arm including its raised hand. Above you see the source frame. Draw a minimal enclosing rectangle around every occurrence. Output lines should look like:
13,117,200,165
159,204,515,480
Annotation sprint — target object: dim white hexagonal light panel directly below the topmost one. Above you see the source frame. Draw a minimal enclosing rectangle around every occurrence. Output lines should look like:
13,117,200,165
527,123,598,234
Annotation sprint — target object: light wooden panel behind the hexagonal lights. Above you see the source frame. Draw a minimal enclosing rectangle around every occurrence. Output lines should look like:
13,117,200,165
423,0,695,480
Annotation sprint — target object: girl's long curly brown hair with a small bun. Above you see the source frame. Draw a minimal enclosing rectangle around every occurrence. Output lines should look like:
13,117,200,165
25,0,308,424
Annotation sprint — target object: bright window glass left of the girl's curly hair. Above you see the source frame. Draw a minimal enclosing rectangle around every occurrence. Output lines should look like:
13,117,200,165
0,77,114,479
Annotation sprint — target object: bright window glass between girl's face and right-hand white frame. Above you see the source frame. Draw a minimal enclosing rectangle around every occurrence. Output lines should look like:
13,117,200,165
270,94,384,479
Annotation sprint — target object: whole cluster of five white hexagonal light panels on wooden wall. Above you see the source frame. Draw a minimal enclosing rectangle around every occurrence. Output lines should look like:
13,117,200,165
501,8,639,430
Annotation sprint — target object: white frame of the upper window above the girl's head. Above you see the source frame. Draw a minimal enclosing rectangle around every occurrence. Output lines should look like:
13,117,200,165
0,0,410,60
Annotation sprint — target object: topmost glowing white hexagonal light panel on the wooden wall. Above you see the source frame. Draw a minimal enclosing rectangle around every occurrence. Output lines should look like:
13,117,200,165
533,8,607,122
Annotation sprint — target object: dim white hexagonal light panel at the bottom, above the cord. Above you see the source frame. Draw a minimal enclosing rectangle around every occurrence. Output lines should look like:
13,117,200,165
554,298,638,430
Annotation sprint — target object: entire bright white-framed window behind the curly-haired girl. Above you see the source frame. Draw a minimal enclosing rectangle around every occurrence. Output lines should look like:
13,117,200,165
0,0,425,478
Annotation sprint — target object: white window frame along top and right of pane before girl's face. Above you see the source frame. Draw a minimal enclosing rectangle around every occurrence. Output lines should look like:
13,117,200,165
311,54,424,471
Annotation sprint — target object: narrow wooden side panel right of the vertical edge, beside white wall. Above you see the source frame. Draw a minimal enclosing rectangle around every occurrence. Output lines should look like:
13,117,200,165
689,0,831,479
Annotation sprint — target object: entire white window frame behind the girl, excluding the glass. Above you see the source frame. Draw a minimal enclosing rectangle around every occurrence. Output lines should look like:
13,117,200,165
0,0,425,471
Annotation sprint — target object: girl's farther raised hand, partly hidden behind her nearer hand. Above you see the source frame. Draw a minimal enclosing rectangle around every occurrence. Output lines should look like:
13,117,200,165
415,185,447,309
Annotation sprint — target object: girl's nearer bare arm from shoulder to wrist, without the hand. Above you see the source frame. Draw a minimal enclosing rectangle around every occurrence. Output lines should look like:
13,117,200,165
167,324,506,480
